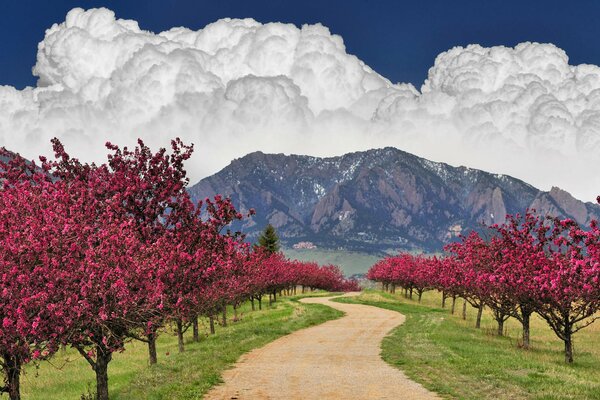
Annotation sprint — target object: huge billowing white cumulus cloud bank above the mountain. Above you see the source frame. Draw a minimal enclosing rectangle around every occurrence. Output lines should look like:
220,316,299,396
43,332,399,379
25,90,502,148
0,9,600,200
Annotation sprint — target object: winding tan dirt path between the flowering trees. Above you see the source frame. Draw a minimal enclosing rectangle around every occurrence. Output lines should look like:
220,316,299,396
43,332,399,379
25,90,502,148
204,297,438,400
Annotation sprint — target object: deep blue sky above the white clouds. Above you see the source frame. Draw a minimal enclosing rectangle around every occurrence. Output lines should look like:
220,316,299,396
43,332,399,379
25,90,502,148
0,0,600,88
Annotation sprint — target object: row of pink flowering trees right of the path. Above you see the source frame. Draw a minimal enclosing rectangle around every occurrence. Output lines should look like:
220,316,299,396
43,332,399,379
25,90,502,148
367,212,600,363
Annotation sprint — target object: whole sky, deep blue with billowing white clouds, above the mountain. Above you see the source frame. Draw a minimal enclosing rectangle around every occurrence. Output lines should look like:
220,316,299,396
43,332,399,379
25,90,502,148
0,0,600,201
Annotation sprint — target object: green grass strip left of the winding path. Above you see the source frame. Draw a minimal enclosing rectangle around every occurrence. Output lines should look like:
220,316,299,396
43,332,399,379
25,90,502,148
22,294,342,400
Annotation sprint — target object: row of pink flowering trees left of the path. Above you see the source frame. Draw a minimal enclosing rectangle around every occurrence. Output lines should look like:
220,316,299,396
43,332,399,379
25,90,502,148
0,140,357,400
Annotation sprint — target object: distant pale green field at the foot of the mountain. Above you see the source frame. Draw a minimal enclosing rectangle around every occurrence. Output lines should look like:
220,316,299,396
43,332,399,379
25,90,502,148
283,249,381,276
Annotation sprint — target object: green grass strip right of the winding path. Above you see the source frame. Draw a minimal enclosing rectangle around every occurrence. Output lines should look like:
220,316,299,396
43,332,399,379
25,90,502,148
336,291,600,400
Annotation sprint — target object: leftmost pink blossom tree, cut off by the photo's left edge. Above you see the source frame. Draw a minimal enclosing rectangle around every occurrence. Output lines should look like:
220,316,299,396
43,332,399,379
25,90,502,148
0,153,68,400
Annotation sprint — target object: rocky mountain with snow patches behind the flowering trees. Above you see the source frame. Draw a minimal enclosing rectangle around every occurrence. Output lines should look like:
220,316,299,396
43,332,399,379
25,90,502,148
189,147,600,253
